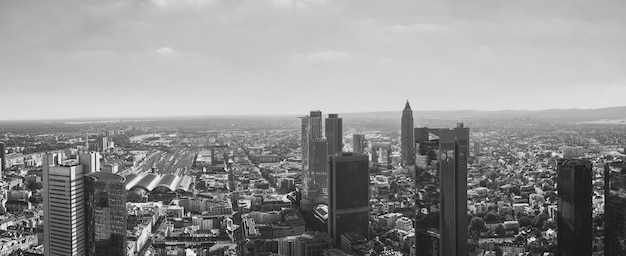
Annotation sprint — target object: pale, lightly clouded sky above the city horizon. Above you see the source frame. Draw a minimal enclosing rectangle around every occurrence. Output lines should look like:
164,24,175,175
0,0,626,120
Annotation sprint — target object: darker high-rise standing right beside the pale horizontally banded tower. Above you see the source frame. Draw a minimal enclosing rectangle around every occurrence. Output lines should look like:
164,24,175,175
85,172,126,256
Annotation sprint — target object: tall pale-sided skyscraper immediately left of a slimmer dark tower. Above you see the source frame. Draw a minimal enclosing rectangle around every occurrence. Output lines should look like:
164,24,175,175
300,110,322,209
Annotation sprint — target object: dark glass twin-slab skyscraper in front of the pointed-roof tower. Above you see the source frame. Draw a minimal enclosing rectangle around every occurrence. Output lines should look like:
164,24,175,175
414,123,469,256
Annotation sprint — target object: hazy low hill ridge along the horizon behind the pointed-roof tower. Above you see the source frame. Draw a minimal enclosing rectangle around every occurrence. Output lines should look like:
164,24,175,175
340,106,626,123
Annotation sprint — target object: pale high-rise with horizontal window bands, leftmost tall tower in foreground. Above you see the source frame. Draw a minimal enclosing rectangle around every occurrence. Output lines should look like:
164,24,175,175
43,154,86,256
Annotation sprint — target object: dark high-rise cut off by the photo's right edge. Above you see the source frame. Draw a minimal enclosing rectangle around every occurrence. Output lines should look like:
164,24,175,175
604,164,626,255
